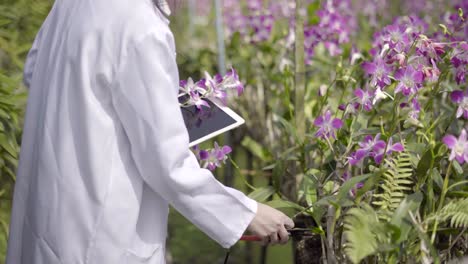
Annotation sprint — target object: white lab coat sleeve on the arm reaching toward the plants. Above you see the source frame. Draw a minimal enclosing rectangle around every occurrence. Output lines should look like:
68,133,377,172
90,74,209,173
111,32,257,248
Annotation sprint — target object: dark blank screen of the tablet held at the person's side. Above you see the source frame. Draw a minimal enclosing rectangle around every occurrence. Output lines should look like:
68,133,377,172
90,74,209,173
179,97,237,142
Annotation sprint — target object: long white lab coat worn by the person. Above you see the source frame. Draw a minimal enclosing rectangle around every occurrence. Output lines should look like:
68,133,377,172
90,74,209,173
6,0,257,264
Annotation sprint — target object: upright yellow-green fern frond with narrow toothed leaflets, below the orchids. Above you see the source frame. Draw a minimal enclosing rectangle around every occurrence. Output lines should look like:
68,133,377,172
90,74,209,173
372,152,413,219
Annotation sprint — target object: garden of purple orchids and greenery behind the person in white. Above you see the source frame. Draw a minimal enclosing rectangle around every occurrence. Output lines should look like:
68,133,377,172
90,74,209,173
0,0,468,264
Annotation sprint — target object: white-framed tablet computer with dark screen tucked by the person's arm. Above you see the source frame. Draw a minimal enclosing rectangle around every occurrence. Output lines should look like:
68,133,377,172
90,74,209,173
179,95,245,147
